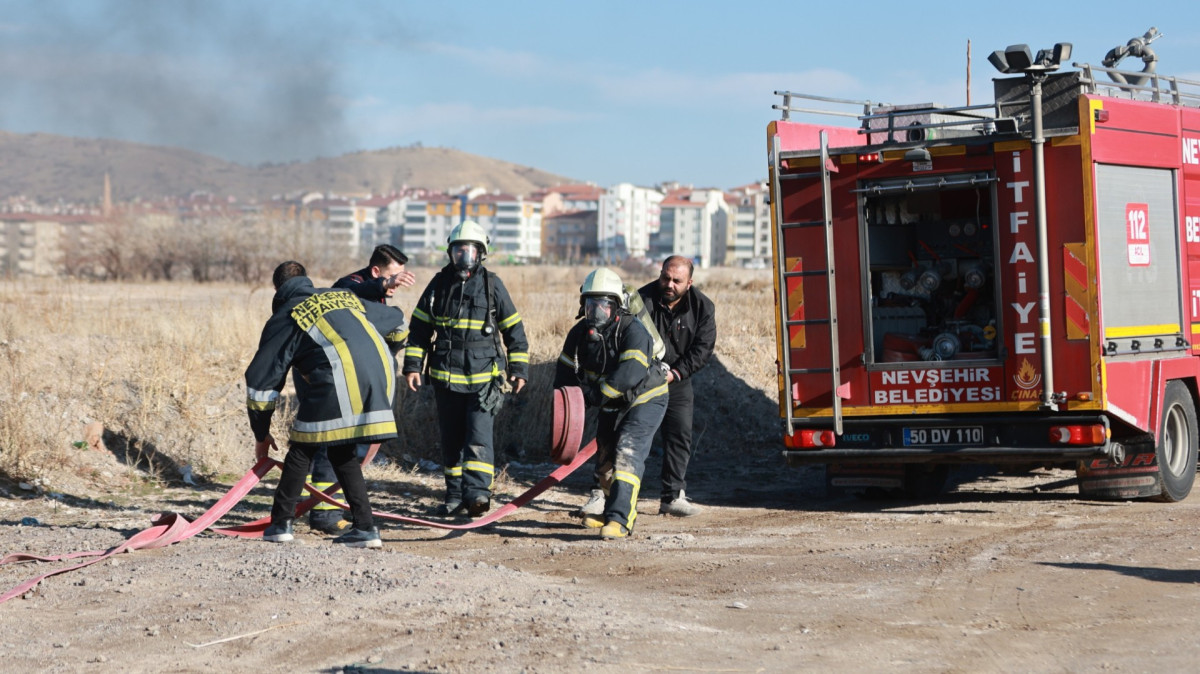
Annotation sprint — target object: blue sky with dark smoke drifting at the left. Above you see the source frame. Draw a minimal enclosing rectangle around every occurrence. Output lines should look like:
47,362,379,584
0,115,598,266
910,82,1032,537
0,0,1200,188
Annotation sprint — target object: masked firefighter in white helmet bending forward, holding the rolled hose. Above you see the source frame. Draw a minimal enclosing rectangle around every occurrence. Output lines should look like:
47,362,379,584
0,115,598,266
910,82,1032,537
554,267,667,540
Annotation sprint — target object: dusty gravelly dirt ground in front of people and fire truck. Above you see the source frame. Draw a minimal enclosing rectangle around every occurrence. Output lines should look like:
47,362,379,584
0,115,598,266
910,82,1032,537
0,450,1200,673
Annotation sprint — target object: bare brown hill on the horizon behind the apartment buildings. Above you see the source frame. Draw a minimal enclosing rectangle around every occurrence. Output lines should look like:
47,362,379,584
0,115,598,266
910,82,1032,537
0,131,572,201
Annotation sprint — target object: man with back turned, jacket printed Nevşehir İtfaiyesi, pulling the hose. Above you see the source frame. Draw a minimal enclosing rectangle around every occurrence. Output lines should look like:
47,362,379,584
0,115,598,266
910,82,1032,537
246,261,408,548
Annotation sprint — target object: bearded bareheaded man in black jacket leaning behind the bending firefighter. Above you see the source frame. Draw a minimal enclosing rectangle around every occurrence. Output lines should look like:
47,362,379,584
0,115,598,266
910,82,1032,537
637,255,716,517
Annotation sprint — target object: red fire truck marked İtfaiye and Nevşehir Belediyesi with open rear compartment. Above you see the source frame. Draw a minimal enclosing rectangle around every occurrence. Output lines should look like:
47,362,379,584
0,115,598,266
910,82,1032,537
767,35,1200,501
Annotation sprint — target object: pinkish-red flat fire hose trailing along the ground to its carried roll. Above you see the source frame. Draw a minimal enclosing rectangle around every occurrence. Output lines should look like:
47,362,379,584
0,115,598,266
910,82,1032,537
0,386,596,603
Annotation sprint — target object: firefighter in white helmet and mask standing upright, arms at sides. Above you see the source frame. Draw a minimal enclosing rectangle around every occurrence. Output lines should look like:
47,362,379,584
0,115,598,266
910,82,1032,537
404,219,529,517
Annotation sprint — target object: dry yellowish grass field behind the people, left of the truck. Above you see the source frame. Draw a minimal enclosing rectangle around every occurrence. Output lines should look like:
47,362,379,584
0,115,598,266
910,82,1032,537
0,266,779,494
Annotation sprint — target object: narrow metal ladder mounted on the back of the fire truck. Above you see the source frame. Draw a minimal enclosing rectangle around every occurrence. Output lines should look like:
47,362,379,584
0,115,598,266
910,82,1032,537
770,131,842,435
